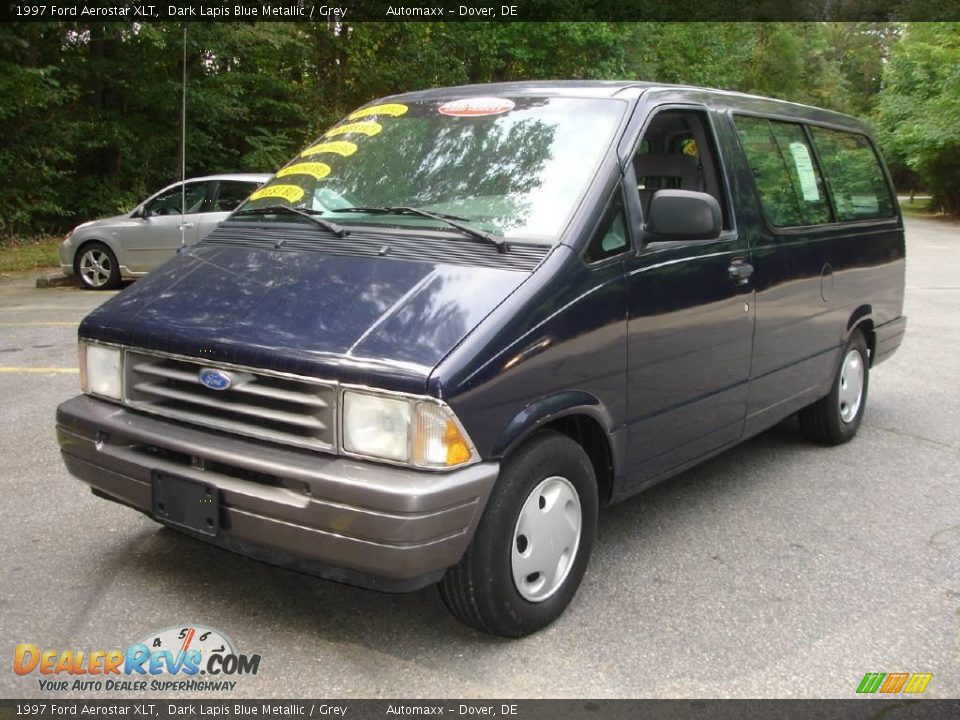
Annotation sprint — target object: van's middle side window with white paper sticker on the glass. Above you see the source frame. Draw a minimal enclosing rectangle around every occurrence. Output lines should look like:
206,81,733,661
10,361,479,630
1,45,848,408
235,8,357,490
735,116,831,227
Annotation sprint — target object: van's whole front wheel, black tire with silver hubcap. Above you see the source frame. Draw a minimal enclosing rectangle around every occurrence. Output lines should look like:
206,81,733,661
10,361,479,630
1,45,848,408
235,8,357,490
440,431,598,637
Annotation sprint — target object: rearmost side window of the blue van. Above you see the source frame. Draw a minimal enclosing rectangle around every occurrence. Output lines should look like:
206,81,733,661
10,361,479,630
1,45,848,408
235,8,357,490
810,127,894,220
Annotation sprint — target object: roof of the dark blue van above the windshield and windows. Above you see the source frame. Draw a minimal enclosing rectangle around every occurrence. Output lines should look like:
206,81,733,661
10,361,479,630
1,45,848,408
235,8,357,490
380,80,869,133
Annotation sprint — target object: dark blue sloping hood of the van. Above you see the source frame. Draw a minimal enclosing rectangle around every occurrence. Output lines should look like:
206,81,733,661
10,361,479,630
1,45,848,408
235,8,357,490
80,244,529,392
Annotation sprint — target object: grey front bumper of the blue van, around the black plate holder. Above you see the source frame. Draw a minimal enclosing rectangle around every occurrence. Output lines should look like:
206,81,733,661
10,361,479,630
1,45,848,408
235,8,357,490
57,395,499,591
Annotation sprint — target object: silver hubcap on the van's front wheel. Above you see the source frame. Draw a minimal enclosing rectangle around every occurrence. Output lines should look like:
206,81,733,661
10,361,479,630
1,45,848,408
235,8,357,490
510,476,583,602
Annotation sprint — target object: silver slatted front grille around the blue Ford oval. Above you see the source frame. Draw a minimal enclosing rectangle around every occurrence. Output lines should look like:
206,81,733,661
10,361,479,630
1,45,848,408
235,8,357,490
124,350,337,452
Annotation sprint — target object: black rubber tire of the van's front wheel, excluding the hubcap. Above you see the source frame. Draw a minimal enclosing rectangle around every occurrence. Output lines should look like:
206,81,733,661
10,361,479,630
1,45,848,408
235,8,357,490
440,431,598,638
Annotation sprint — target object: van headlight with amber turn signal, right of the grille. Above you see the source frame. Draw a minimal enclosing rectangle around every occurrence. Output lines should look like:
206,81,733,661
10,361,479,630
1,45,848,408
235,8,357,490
342,390,474,469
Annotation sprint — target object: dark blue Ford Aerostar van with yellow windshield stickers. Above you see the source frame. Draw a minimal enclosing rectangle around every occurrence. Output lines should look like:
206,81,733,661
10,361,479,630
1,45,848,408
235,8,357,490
57,82,906,636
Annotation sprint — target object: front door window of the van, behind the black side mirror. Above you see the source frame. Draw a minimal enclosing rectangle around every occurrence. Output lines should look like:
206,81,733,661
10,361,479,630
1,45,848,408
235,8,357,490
633,109,730,228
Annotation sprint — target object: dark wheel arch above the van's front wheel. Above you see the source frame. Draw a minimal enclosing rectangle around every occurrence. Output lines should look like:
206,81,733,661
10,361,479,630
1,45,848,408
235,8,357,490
494,391,616,505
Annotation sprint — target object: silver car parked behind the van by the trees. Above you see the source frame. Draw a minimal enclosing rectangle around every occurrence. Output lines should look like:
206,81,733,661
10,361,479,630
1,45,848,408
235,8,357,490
60,174,271,290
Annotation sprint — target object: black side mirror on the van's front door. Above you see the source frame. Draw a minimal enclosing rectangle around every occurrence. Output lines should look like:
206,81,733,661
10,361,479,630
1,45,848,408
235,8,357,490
643,190,723,242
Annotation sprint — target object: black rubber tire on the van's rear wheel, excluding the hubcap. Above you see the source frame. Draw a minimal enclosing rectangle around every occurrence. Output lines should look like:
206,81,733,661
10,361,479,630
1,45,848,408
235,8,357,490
800,330,870,445
